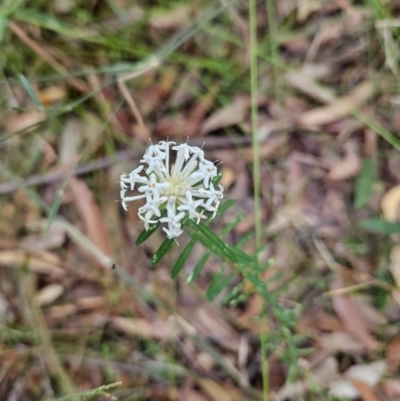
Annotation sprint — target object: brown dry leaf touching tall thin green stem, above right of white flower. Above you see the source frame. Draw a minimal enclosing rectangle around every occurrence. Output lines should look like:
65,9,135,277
200,95,251,135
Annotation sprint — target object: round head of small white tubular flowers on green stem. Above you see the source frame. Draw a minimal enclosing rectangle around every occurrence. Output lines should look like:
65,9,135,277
120,141,224,239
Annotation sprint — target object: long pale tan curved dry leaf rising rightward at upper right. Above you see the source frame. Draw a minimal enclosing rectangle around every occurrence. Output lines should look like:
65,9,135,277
298,81,374,128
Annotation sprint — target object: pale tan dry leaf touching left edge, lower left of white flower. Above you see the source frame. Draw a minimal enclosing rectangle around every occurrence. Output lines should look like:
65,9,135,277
0,249,64,275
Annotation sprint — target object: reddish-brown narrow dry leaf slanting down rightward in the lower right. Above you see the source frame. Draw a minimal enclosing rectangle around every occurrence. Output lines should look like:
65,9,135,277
332,288,379,351
